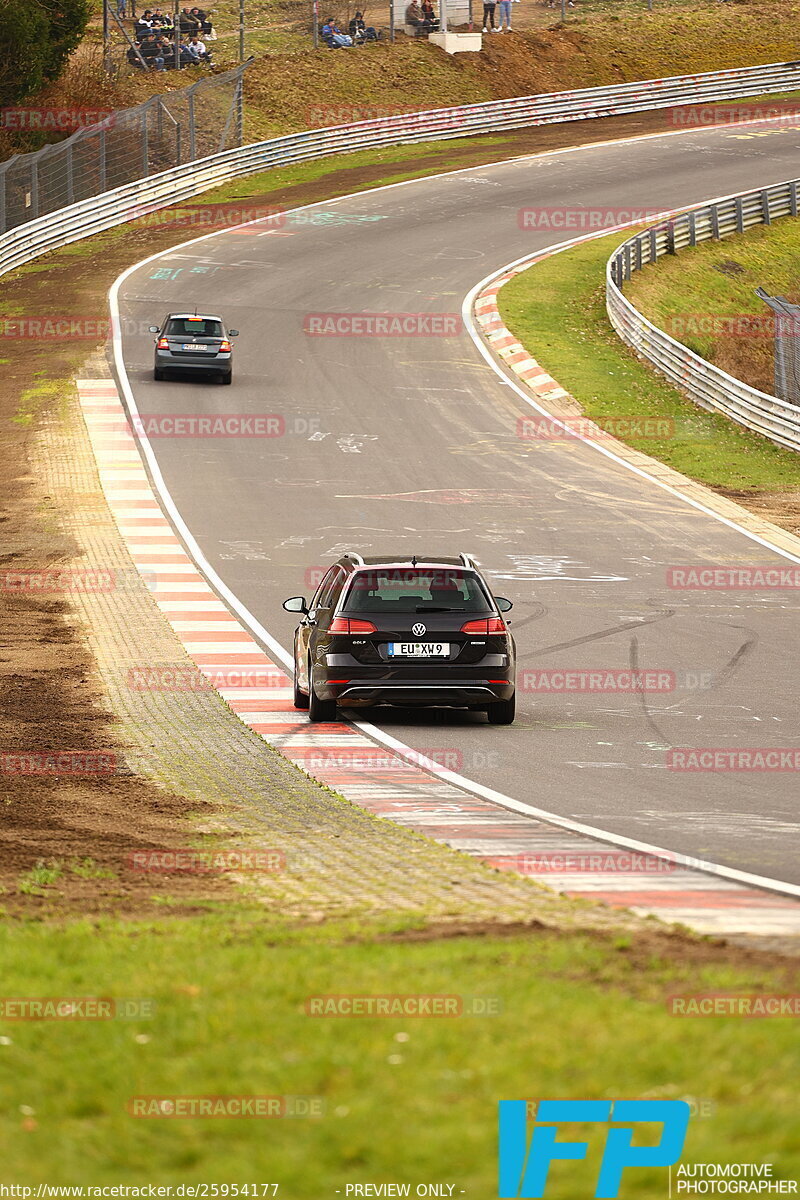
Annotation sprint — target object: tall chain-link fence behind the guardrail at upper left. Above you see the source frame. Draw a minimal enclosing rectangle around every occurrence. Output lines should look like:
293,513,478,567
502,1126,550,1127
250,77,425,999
0,60,252,233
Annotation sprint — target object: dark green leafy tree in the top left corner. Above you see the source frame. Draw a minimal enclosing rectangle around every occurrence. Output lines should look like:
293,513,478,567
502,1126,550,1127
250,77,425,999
0,0,90,106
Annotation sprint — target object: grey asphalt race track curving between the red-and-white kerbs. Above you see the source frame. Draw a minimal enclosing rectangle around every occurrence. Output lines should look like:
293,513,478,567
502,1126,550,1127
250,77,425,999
113,126,800,883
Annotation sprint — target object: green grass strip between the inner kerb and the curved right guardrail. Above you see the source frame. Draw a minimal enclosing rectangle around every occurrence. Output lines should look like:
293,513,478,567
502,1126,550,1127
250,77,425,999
499,234,800,494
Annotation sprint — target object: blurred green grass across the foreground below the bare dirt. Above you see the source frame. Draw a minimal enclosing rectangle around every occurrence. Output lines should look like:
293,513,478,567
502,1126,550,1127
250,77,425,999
0,906,800,1185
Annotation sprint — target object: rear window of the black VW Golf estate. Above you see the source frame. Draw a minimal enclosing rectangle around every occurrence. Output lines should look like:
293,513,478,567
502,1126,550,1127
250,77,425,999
342,566,492,613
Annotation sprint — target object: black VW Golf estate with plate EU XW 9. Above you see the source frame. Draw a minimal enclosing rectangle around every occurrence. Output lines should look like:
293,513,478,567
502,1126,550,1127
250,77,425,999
283,554,515,725
